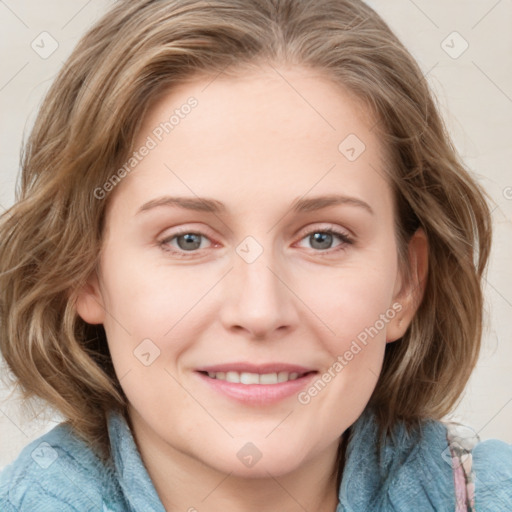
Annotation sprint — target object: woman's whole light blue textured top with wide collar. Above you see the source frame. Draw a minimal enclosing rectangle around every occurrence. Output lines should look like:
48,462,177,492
0,409,512,512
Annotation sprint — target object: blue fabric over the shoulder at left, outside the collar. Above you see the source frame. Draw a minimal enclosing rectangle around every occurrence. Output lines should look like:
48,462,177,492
0,423,124,512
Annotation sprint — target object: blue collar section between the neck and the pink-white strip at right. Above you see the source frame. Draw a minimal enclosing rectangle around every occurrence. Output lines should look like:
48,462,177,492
340,409,455,512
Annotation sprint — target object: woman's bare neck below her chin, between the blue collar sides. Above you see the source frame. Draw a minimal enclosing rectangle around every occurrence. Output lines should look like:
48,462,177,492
130,411,340,512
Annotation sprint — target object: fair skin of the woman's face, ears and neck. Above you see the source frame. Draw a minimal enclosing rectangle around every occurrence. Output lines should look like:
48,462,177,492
77,67,427,512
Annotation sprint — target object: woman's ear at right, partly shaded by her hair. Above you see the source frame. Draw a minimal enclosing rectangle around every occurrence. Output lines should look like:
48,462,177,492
386,228,428,343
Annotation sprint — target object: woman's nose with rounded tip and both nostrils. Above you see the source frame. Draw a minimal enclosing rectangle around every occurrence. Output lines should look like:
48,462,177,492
221,241,299,339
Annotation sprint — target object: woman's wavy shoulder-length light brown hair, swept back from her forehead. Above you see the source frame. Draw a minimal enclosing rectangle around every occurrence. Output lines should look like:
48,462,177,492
0,0,491,476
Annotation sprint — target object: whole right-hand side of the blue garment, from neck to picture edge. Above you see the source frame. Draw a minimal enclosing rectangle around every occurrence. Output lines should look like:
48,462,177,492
340,410,512,512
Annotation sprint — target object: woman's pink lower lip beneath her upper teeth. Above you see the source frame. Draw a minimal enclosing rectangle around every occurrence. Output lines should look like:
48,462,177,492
196,372,316,405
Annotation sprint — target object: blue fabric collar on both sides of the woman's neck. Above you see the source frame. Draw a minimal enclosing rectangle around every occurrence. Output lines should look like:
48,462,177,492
108,409,455,512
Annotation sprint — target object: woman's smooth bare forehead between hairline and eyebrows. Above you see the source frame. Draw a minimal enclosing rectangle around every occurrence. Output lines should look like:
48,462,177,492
106,67,386,216
